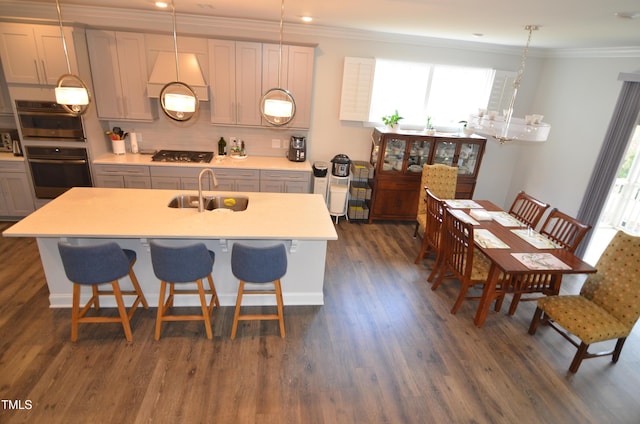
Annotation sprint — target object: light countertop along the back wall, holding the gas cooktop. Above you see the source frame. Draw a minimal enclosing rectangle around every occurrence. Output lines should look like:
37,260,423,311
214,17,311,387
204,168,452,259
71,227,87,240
93,153,311,172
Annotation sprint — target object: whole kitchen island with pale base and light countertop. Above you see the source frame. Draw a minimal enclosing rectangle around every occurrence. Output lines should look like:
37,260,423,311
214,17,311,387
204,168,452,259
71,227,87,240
3,187,338,307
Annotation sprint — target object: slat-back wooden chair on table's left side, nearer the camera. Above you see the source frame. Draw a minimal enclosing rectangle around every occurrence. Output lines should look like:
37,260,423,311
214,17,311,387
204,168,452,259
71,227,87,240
431,207,498,314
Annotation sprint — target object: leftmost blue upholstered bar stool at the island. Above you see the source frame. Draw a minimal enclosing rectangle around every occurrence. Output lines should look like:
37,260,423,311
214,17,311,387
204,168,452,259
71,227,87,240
58,242,149,342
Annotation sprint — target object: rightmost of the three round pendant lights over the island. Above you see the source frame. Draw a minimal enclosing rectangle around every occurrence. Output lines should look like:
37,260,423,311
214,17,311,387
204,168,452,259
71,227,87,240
260,0,296,127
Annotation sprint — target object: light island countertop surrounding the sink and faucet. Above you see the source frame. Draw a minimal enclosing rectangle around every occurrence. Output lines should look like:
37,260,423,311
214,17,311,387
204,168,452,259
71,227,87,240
3,186,338,240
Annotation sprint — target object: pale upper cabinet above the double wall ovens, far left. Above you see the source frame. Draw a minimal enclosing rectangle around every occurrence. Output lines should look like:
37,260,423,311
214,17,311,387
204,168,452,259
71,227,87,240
0,22,78,85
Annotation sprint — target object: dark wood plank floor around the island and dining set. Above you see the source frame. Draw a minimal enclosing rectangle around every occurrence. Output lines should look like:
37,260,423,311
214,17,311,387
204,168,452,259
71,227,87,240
0,222,640,423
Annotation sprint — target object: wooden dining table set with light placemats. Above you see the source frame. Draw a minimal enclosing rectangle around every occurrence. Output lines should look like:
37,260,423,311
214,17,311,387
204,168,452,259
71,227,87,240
445,200,596,327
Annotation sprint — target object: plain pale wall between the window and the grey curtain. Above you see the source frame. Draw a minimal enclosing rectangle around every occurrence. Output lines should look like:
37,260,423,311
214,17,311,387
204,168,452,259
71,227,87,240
509,57,640,215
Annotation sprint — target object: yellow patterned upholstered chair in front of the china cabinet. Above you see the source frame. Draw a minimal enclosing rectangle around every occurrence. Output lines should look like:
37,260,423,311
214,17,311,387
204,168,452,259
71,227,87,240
413,163,458,237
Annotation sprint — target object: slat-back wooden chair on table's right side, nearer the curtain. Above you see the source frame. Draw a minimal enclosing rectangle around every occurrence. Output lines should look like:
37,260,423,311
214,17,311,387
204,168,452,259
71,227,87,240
509,208,591,315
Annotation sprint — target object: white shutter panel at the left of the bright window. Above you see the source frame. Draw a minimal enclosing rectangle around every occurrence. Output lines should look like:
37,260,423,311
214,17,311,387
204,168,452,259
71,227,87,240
340,57,376,122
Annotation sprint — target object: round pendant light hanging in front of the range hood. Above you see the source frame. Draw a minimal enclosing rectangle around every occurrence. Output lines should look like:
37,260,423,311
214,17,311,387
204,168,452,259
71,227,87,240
160,0,200,121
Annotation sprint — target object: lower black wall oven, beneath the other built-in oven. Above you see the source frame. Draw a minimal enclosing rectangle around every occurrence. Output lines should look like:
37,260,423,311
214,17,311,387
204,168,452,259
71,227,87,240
26,146,92,199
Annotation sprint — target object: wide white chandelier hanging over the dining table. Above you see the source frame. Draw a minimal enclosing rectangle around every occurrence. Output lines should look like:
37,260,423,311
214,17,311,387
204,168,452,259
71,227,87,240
467,25,551,144
